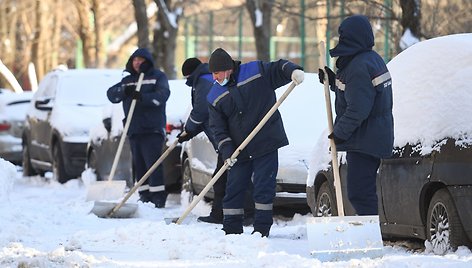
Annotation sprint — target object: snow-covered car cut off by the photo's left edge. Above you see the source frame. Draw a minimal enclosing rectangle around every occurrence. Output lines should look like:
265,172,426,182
0,89,33,164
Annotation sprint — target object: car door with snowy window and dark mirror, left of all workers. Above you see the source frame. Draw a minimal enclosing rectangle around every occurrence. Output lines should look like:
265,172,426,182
28,74,58,166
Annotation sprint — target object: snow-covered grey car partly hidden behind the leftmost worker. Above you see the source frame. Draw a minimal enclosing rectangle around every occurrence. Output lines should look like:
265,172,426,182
87,80,190,191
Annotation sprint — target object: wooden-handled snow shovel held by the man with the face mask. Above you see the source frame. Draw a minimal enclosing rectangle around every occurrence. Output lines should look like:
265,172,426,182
164,82,296,224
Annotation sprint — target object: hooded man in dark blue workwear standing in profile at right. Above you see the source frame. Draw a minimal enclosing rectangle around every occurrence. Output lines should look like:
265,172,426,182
319,15,393,215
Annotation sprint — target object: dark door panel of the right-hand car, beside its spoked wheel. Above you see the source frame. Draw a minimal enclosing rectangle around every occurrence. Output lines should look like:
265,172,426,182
378,145,434,235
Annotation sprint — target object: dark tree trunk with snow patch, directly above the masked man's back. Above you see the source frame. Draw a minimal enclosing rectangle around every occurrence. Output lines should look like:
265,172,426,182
246,0,274,61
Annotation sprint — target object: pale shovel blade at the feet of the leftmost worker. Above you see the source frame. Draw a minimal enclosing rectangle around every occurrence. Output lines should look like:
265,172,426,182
86,180,126,201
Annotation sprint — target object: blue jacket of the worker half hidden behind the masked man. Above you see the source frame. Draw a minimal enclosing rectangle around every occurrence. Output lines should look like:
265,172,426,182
185,63,217,149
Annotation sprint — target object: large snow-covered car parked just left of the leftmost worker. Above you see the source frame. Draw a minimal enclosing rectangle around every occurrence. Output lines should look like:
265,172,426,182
22,69,123,183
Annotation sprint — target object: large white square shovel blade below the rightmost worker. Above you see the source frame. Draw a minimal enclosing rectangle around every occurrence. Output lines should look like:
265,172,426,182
307,216,383,261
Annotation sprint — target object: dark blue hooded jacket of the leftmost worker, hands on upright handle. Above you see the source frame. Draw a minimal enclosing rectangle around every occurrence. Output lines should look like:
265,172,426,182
107,48,170,136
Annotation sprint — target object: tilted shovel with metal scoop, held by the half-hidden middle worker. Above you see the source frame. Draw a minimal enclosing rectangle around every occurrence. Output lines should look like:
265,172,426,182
92,137,181,218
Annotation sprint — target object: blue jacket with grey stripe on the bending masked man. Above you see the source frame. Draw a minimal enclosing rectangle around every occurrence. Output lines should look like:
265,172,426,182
208,60,302,161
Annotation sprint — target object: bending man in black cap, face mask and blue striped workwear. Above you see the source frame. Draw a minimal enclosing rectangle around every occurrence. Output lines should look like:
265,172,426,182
208,48,304,236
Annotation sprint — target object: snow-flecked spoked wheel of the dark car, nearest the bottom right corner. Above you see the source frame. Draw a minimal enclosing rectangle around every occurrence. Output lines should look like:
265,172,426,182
426,189,467,254
